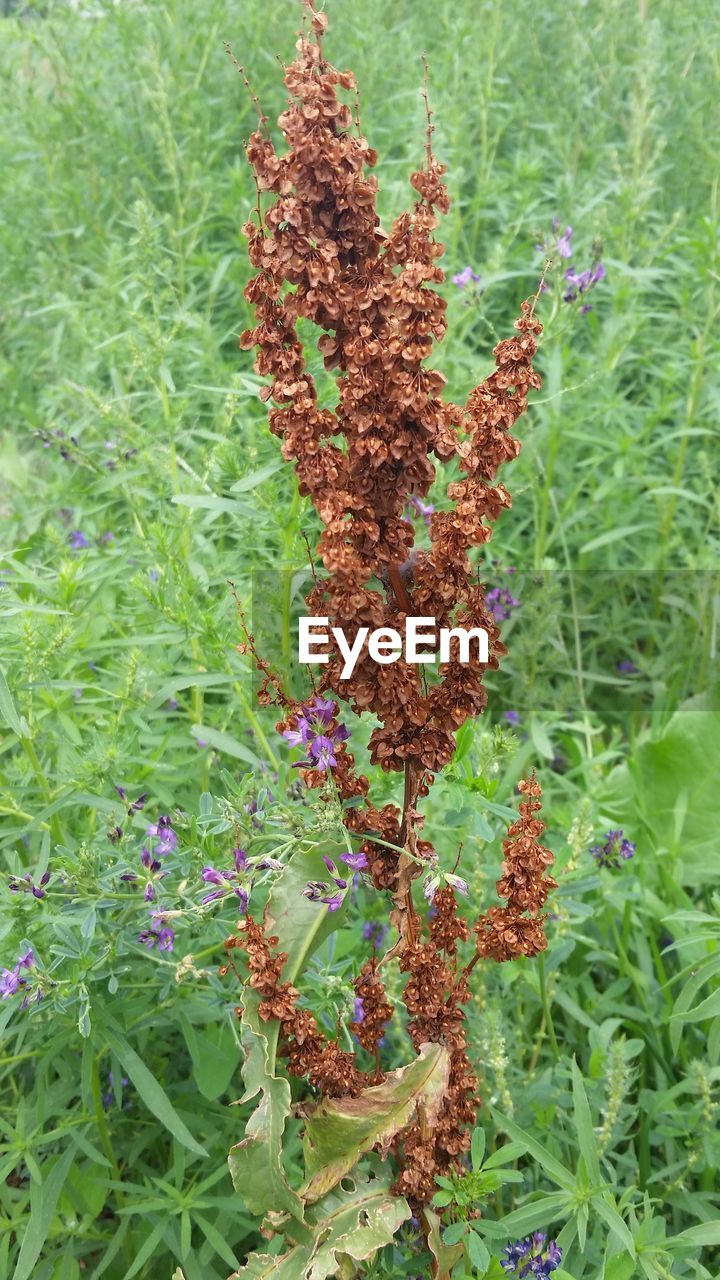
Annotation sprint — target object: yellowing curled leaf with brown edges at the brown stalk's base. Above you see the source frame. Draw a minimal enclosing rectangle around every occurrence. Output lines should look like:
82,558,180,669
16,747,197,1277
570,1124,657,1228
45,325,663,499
301,1044,450,1203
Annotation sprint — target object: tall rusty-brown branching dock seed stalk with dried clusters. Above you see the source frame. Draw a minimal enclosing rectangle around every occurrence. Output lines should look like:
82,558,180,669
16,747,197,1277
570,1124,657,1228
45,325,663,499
228,0,555,1239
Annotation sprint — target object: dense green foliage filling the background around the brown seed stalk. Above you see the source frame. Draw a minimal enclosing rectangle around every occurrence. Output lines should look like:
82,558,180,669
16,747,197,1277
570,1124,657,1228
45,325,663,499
0,0,720,1280
